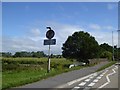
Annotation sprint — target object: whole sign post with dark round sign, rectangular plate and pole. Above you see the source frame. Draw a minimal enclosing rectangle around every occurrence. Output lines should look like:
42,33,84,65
44,27,56,73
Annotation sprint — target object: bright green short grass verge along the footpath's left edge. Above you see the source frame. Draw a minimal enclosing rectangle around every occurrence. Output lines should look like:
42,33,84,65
2,66,86,89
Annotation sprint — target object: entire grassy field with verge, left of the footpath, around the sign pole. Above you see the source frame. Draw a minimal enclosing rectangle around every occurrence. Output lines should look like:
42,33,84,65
2,58,78,89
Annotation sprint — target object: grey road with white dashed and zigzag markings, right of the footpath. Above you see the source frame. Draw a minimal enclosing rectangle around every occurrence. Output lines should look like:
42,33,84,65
67,65,119,90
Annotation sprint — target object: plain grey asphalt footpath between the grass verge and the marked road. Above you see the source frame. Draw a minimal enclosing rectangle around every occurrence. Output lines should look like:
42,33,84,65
17,61,108,88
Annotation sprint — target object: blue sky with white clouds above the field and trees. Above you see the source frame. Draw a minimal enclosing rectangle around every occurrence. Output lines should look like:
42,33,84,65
2,2,118,54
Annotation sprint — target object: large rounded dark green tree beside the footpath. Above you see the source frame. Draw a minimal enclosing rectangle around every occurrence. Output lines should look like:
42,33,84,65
62,31,99,61
